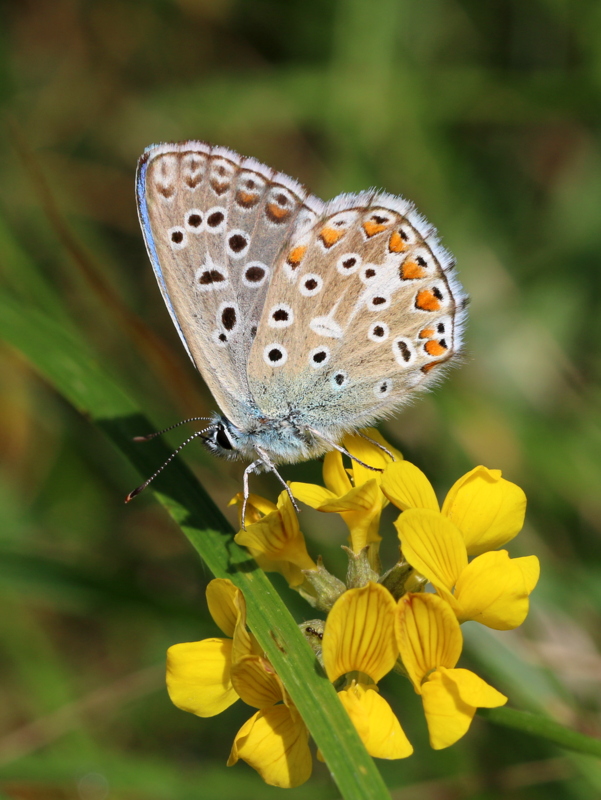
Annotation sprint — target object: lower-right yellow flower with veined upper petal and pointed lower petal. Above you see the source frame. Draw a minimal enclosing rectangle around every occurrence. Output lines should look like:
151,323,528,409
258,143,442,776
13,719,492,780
396,594,507,750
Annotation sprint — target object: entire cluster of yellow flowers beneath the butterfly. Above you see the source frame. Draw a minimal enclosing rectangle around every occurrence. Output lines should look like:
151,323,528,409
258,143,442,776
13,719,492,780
167,429,539,787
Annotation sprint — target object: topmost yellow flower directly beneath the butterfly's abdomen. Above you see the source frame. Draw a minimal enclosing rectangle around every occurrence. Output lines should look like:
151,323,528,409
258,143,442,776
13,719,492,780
290,428,403,553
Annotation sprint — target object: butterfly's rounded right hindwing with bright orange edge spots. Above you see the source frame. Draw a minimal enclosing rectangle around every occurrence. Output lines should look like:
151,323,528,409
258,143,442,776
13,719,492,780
248,192,466,437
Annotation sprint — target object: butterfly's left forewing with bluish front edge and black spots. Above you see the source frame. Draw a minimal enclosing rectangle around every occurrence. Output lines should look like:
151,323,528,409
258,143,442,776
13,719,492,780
137,142,323,426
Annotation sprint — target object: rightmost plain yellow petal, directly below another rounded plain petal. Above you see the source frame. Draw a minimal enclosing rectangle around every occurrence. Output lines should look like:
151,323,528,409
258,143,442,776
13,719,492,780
455,550,539,631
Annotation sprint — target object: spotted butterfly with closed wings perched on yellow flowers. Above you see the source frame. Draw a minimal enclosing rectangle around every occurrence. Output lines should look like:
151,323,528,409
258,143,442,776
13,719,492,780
128,141,467,519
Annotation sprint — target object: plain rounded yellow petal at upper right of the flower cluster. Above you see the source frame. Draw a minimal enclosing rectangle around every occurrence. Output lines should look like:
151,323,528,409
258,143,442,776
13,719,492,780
442,466,526,556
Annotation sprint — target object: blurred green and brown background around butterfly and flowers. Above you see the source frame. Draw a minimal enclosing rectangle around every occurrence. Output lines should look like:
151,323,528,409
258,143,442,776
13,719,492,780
0,0,601,800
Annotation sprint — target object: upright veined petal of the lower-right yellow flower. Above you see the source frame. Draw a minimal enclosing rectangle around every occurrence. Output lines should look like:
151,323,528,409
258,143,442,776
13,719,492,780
395,594,463,694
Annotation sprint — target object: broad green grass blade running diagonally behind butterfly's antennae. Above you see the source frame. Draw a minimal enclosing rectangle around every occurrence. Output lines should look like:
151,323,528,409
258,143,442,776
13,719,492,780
0,294,390,800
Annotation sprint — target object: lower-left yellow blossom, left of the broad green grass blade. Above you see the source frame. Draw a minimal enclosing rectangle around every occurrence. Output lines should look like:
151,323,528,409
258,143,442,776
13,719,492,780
167,579,313,788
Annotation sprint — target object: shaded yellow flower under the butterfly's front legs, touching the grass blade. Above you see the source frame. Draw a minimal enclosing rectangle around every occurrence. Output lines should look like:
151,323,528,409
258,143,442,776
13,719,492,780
234,491,317,586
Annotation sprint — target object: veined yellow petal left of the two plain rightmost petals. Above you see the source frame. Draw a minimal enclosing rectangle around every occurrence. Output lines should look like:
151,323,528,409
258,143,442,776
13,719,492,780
394,508,467,601
